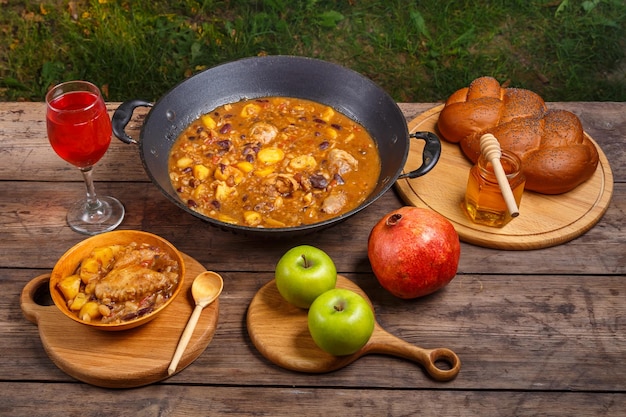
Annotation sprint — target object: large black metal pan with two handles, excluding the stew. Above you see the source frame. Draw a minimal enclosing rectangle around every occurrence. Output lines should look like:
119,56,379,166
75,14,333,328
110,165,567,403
113,56,441,237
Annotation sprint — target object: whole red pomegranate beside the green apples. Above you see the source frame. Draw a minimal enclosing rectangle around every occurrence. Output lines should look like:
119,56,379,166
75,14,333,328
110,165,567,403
367,207,461,299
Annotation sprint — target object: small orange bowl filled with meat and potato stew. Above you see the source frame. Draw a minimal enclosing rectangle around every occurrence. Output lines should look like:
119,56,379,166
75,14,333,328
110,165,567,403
50,230,185,330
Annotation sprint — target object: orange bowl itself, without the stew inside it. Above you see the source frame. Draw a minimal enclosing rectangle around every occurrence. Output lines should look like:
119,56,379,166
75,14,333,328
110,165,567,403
50,230,185,331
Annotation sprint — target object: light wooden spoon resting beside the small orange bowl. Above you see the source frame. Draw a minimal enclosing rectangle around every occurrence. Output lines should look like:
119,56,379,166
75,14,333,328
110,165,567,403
167,271,224,375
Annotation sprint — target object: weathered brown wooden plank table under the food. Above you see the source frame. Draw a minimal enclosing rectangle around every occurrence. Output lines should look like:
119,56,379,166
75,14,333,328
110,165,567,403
0,102,626,417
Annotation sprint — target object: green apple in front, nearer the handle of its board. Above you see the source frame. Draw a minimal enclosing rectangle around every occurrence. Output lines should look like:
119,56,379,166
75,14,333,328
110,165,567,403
308,288,375,356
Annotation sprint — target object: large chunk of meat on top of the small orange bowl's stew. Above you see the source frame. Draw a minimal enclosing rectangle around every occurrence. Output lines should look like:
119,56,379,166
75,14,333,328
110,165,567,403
95,264,178,302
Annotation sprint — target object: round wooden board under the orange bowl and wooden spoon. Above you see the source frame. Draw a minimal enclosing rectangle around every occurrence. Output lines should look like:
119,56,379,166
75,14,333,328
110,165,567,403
21,254,219,388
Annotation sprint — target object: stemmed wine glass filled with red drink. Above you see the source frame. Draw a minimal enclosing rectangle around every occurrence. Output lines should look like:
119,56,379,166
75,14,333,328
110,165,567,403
46,81,124,235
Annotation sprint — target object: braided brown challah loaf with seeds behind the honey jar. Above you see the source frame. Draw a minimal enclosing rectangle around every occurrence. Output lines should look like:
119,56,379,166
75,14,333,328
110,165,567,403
437,77,598,194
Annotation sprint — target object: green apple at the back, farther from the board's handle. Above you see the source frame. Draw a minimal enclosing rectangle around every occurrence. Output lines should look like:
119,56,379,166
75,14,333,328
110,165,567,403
275,245,337,308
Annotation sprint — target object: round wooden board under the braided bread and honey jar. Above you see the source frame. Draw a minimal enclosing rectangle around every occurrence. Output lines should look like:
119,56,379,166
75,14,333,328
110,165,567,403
395,105,613,250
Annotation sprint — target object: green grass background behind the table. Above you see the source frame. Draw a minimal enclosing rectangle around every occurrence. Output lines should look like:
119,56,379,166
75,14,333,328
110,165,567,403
0,0,626,102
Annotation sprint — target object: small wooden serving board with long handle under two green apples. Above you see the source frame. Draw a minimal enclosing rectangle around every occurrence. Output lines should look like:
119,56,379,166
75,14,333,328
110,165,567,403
247,275,461,381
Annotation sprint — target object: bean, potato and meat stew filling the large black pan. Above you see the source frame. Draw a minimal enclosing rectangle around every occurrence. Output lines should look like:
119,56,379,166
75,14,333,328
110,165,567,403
169,97,380,227
